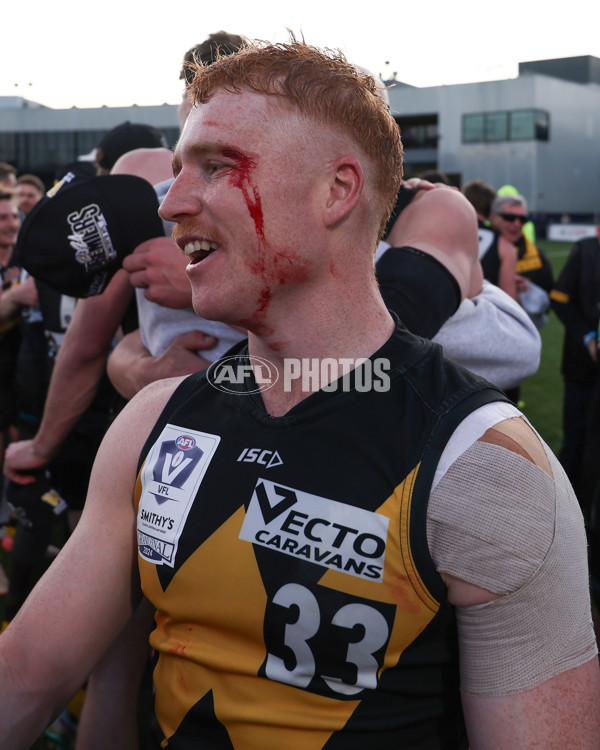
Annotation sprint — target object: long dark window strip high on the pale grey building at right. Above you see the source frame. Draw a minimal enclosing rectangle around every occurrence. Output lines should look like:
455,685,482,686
462,109,550,143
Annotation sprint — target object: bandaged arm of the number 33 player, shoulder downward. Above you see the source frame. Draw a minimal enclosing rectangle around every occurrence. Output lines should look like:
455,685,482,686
436,419,600,750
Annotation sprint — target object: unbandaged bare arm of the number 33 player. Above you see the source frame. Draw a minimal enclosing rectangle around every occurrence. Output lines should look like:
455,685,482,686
0,381,182,750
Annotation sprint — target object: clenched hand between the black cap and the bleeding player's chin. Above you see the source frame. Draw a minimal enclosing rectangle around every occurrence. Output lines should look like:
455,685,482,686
123,237,192,309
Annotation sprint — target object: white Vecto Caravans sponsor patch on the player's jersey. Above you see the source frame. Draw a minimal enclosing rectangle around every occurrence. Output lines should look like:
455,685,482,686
240,479,389,582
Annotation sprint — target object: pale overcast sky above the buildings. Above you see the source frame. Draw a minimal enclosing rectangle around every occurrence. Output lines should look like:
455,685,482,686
0,0,600,110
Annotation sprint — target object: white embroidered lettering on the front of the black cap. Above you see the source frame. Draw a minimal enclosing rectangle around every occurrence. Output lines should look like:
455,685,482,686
67,203,117,273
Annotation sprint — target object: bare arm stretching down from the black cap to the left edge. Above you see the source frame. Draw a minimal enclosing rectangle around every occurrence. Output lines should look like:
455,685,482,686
4,271,132,484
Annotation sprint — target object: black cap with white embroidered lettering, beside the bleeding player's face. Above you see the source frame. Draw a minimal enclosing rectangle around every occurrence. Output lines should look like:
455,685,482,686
16,172,164,297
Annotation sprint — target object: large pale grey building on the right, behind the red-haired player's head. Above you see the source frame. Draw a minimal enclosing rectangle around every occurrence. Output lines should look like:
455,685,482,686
389,56,600,218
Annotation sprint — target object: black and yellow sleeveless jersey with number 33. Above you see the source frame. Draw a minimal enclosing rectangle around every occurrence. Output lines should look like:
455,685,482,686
136,325,503,750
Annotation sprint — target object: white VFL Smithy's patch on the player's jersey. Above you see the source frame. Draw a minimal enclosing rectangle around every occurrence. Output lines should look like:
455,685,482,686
137,424,221,567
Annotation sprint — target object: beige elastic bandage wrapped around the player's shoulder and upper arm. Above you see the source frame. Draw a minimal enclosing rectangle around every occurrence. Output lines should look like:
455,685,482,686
427,434,596,695
